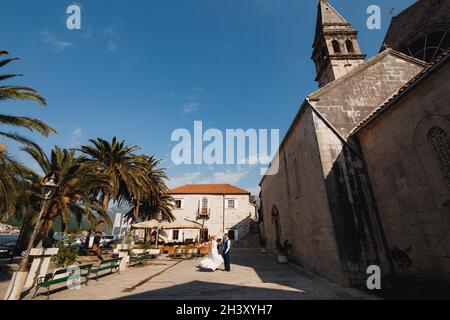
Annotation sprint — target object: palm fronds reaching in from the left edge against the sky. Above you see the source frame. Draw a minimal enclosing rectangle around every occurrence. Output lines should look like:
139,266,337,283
0,51,56,220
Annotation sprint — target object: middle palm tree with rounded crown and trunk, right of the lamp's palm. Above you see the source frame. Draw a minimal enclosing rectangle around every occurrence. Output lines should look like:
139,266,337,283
79,137,154,253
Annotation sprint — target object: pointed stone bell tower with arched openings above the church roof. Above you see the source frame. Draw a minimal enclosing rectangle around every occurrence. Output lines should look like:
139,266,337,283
312,0,366,87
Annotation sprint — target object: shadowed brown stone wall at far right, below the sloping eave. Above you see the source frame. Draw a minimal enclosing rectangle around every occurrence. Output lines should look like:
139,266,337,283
358,58,450,279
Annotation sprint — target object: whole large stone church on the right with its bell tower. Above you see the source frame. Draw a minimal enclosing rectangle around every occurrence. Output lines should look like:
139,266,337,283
260,0,450,285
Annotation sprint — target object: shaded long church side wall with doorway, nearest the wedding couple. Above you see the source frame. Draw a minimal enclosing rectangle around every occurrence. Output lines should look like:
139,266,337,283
261,105,348,284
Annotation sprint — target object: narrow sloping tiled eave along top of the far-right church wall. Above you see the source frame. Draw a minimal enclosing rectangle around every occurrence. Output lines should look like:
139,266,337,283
352,49,450,134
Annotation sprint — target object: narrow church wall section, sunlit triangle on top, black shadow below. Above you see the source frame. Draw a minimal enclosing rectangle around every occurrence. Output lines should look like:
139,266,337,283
314,112,388,286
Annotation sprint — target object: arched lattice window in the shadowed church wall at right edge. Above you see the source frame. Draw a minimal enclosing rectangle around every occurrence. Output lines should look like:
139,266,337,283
428,127,450,189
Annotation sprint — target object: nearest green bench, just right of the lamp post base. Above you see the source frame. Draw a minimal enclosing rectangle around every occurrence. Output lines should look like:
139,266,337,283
33,264,93,299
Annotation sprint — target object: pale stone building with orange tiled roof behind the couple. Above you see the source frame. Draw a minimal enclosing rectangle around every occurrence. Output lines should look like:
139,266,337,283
166,184,257,246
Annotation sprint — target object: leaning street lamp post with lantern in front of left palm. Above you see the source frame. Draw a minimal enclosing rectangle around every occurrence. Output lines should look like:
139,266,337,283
5,176,58,300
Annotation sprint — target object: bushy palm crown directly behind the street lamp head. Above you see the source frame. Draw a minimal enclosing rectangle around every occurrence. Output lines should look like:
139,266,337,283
23,147,111,245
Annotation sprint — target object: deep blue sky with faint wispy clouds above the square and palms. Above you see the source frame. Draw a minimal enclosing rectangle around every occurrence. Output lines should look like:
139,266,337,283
0,0,414,193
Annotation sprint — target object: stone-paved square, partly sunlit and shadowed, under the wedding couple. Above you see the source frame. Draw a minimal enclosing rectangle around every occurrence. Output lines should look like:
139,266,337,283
16,249,373,300
